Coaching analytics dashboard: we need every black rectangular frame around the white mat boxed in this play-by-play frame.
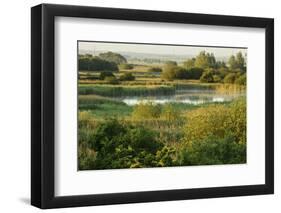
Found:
[31,4,274,209]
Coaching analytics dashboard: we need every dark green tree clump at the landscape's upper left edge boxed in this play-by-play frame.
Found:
[78,55,118,71]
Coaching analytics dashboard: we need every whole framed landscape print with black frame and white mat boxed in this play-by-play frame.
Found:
[31,4,274,208]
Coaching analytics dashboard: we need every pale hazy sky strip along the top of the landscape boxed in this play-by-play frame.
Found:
[78,41,247,57]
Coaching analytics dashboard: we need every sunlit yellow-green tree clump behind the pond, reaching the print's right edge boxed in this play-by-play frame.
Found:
[162,51,246,85]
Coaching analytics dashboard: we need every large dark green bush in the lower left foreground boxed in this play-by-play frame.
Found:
[79,120,164,170]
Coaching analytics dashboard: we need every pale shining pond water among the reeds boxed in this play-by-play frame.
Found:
[121,90,245,106]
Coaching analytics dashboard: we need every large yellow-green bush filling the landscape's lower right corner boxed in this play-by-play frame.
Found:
[178,100,246,165]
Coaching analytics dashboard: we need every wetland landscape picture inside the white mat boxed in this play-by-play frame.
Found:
[77,41,247,171]
